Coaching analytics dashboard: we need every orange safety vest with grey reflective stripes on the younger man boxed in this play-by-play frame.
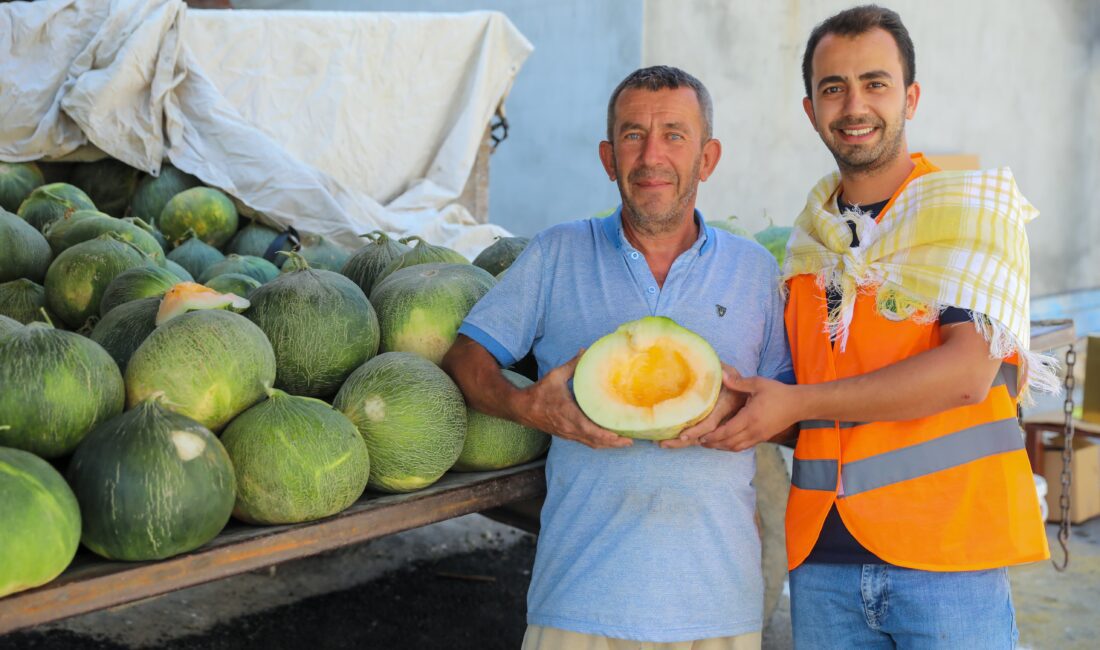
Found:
[785,154,1049,571]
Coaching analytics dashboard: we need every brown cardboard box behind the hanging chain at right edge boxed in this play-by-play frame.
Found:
[1043,436,1100,524]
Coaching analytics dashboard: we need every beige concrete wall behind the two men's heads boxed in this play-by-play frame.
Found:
[642,0,1100,296]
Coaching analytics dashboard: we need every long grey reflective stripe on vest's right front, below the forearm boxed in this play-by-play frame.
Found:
[843,418,1024,497]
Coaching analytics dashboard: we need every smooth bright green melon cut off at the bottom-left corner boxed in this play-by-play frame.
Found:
[0,447,80,598]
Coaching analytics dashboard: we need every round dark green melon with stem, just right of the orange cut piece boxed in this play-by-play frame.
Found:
[243,253,378,397]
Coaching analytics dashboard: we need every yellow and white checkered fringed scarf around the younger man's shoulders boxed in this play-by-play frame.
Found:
[783,168,1059,393]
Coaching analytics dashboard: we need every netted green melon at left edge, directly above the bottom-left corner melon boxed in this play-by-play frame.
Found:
[0,323,124,459]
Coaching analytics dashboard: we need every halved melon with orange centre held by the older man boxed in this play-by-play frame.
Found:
[573,317,722,440]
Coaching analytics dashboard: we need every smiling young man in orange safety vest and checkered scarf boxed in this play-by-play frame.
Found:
[683,5,1054,650]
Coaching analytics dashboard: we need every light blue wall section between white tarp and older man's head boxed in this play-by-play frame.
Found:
[233,0,644,235]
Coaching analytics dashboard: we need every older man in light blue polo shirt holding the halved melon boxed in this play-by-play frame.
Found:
[443,66,793,650]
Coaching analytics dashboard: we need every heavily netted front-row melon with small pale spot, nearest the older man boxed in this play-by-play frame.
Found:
[332,352,466,493]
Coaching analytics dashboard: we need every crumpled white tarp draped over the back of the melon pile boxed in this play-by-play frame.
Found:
[0,0,531,256]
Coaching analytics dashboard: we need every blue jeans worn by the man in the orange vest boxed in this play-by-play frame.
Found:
[791,564,1019,650]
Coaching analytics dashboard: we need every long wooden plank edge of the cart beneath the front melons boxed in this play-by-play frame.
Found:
[0,461,546,634]
